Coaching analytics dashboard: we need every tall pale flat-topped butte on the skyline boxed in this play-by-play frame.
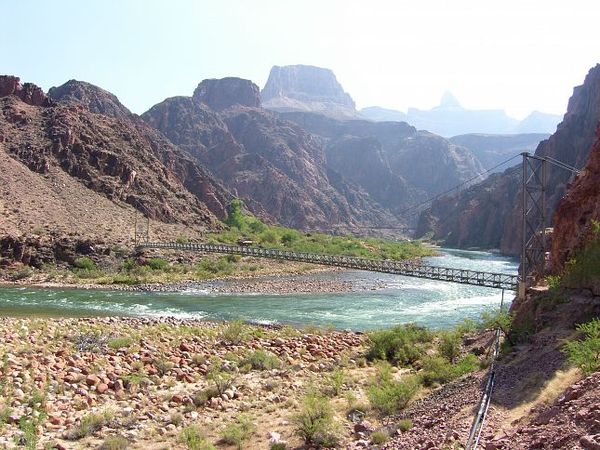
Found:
[261,65,358,118]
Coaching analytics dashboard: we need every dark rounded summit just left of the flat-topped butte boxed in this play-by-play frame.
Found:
[193,77,260,111]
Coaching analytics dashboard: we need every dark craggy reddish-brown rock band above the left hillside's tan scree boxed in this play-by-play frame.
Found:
[0,89,228,226]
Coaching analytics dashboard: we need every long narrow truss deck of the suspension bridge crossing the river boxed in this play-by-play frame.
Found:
[138,242,517,290]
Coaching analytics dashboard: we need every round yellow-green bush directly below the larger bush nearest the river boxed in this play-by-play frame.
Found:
[367,372,420,416]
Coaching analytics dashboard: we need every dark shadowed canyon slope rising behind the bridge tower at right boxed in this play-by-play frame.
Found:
[417,65,600,255]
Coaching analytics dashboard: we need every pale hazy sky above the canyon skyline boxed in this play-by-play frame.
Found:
[0,0,600,118]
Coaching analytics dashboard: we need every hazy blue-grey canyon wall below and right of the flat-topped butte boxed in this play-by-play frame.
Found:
[281,112,483,221]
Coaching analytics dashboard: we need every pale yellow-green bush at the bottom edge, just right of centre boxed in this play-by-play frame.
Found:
[294,393,339,447]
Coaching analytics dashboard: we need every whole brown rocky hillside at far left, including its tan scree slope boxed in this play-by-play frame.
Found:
[0,76,231,266]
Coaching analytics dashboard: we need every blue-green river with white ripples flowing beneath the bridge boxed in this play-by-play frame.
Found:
[0,249,518,331]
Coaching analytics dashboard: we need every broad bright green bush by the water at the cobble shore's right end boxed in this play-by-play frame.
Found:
[367,323,433,365]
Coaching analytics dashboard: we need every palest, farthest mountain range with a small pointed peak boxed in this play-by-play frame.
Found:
[360,92,561,137]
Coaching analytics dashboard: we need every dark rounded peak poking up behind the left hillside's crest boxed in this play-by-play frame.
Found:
[48,80,133,119]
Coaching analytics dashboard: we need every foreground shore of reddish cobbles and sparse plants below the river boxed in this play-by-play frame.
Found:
[0,318,364,449]
